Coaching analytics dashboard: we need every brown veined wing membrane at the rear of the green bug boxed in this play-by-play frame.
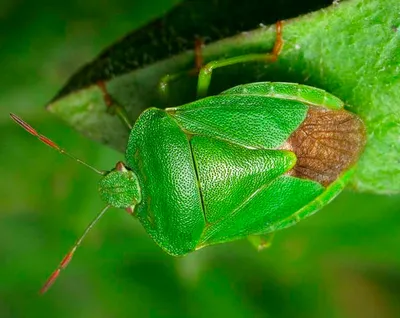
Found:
[282,106,365,186]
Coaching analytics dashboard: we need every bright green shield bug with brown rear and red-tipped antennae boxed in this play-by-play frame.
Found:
[12,21,365,291]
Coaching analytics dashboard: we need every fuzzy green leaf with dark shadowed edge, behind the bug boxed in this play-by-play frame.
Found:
[48,0,400,194]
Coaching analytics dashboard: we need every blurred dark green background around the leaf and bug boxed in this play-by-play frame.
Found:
[0,0,400,317]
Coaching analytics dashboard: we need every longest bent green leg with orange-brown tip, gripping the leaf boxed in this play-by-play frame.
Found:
[197,21,283,98]
